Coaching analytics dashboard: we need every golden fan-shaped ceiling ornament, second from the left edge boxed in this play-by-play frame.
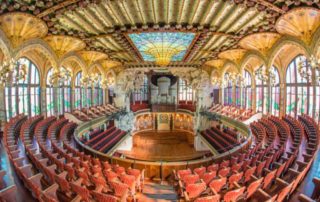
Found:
[44,35,86,58]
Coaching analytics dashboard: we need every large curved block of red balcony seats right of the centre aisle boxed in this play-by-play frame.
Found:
[174,115,320,202]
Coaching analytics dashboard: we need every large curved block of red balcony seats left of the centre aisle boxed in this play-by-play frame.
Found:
[0,115,144,202]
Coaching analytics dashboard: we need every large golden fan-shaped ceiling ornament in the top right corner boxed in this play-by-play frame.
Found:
[276,7,320,43]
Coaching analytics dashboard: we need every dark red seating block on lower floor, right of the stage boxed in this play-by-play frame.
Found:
[200,127,239,153]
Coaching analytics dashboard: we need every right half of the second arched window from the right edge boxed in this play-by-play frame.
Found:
[271,67,280,116]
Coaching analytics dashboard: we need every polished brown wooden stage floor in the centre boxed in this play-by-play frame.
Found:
[117,131,208,161]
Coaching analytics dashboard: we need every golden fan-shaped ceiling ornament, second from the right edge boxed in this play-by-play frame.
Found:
[239,32,281,55]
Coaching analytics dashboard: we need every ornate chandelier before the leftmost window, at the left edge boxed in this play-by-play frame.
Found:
[0,59,27,86]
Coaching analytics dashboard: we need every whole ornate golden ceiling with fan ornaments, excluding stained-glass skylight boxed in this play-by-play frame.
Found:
[0,0,320,71]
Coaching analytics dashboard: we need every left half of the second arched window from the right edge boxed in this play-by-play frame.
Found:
[255,66,269,113]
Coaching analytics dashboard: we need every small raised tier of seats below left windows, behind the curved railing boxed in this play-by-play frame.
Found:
[72,104,119,121]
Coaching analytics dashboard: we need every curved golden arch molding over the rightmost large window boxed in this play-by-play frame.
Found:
[267,36,312,67]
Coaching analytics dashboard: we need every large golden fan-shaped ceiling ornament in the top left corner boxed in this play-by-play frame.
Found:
[0,12,48,48]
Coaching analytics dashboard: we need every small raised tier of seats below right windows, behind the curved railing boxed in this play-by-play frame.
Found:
[209,104,255,121]
